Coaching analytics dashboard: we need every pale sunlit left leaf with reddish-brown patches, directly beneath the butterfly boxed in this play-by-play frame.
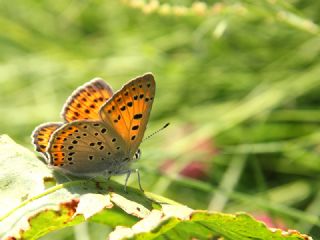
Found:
[0,135,148,239]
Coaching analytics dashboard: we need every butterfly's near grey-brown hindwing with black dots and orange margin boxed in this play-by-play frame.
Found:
[48,120,129,176]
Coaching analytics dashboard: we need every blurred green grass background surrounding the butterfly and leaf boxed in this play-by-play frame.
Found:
[0,0,320,240]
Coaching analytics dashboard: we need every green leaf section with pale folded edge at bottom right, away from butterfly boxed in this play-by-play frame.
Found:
[110,205,311,240]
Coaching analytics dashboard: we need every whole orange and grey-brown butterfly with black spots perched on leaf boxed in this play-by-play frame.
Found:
[32,73,156,189]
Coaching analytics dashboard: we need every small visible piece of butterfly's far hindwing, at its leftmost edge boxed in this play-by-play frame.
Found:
[32,123,62,153]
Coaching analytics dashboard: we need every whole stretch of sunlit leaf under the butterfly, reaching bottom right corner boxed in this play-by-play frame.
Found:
[0,135,311,240]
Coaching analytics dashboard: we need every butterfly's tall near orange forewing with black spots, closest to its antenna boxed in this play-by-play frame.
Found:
[100,73,155,157]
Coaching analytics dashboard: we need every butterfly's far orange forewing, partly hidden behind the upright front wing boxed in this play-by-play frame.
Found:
[61,78,113,122]
